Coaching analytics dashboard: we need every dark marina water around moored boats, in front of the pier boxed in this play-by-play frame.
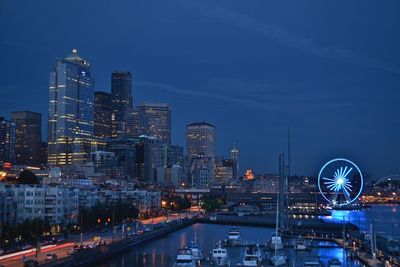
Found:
[96,224,360,267]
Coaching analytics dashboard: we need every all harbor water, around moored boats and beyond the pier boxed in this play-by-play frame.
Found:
[96,205,400,267]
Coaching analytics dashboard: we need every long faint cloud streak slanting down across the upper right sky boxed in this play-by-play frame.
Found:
[180,0,400,74]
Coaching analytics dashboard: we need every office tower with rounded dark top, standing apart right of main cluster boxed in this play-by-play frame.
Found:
[186,122,215,159]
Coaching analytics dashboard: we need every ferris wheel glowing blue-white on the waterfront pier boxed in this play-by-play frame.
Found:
[318,158,364,206]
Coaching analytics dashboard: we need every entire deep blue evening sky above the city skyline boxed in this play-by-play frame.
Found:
[0,0,400,179]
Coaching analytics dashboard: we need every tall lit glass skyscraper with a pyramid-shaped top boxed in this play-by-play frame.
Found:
[48,49,94,166]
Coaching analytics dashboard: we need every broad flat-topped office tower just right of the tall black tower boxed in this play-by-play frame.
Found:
[132,103,171,145]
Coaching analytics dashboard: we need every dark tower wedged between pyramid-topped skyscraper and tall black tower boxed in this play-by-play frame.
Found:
[94,92,112,138]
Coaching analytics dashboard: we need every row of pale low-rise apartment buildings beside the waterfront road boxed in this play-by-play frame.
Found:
[0,184,161,226]
